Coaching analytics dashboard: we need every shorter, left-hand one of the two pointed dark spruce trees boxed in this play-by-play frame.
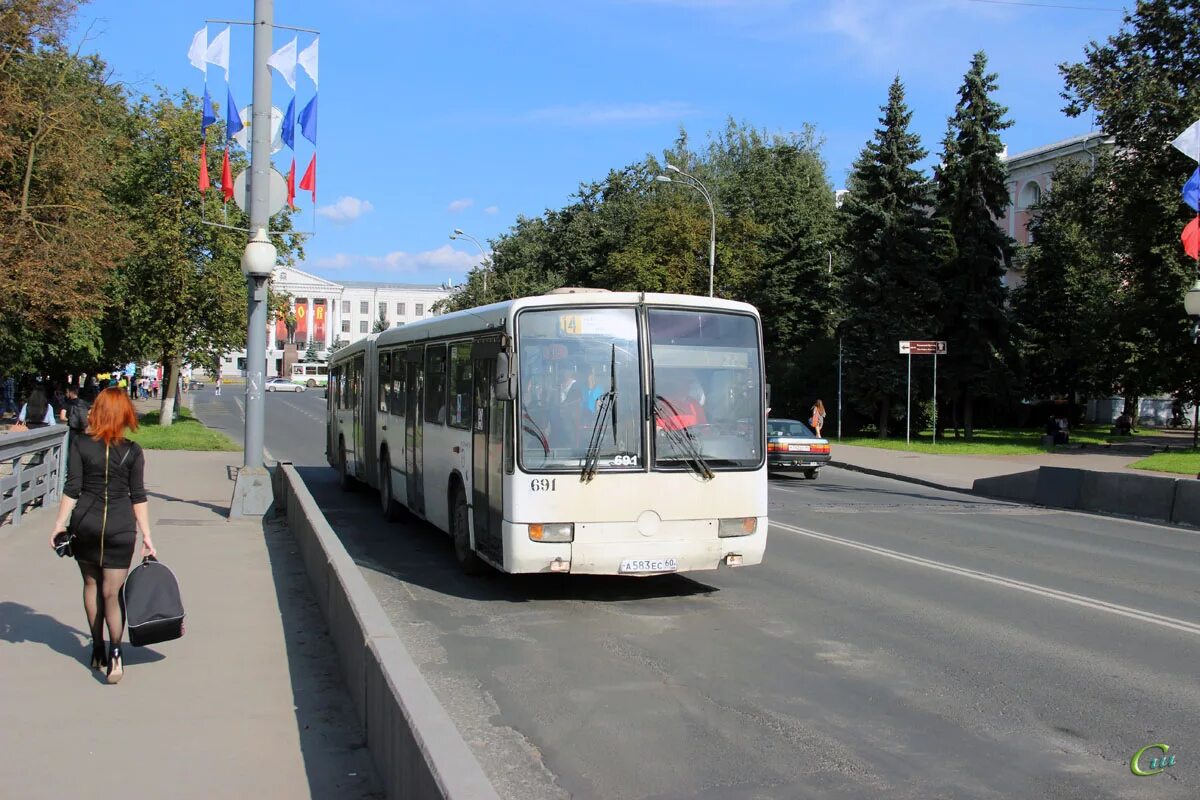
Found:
[842,76,938,438]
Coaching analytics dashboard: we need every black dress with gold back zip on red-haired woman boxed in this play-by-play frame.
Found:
[64,435,146,570]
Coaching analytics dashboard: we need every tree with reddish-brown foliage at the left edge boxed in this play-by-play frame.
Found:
[0,0,128,371]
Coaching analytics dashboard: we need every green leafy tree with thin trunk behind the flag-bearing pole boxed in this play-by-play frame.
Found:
[109,92,301,425]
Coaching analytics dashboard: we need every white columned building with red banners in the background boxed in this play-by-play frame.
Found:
[221,267,452,377]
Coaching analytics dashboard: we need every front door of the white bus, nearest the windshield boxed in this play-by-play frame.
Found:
[470,338,504,565]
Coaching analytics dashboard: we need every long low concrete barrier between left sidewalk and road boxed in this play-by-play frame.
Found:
[275,463,499,800]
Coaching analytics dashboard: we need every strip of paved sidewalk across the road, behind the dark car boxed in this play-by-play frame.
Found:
[830,441,1147,492]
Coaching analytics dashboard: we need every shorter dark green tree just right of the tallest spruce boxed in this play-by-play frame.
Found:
[1013,158,1128,398]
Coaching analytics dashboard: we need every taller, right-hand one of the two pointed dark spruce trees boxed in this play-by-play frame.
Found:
[934,52,1015,439]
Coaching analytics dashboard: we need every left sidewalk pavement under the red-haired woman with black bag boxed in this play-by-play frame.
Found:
[0,451,384,800]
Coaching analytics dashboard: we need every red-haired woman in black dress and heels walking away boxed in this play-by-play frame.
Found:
[50,389,155,684]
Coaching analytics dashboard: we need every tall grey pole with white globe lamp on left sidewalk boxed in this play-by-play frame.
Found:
[229,0,276,517]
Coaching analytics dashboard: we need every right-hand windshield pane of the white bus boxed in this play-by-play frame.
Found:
[649,308,763,473]
